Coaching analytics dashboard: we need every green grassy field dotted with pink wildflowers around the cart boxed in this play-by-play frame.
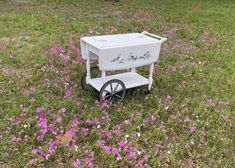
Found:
[0,0,235,168]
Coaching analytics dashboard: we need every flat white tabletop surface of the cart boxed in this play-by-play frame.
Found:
[81,33,161,49]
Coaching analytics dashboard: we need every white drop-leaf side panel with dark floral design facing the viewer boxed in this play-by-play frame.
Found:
[99,43,161,71]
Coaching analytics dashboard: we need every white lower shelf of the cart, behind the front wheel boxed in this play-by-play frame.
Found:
[89,72,149,91]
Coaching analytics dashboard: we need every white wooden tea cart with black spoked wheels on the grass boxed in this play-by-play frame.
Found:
[81,31,167,102]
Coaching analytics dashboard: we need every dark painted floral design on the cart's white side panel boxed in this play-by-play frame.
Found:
[110,51,152,64]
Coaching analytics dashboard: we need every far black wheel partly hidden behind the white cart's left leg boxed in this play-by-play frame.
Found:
[81,66,101,91]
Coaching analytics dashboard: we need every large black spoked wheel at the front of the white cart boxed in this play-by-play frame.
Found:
[100,79,126,103]
